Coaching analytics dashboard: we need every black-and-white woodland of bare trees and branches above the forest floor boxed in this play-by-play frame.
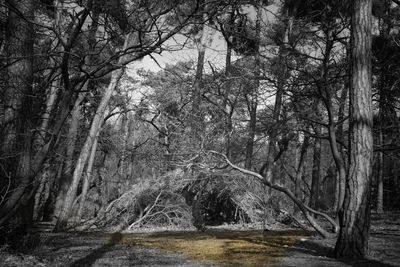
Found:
[0,0,400,258]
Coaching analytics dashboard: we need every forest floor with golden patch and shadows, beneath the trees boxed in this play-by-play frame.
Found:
[0,215,400,267]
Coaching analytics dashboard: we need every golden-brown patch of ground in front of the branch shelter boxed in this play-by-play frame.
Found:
[114,229,307,266]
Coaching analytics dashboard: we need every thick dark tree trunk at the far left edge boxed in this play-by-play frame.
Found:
[0,0,35,228]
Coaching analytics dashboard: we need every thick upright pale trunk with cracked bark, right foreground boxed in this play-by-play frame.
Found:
[335,0,373,259]
